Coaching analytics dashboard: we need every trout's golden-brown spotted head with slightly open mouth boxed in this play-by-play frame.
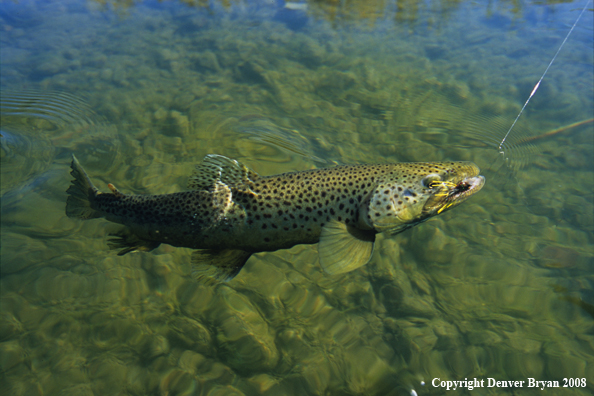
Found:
[359,161,485,234]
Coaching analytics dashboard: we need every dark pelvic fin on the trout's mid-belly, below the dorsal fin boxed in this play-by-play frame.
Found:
[192,249,252,282]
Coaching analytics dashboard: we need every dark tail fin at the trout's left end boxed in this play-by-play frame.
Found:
[66,155,102,220]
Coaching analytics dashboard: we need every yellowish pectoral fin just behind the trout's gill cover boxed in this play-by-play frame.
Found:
[318,220,375,275]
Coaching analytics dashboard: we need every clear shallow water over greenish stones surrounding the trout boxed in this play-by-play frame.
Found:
[0,1,594,395]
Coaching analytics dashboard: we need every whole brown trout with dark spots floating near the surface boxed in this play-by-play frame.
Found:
[66,155,485,280]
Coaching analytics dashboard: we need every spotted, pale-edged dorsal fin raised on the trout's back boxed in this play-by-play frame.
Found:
[188,154,260,190]
